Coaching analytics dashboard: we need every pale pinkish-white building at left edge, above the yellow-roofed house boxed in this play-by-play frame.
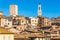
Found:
[0,17,12,27]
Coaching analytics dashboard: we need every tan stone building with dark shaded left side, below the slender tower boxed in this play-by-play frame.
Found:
[38,17,51,27]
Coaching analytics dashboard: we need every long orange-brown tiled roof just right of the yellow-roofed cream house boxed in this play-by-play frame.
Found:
[15,32,44,38]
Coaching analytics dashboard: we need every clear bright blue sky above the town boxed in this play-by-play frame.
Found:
[0,0,60,18]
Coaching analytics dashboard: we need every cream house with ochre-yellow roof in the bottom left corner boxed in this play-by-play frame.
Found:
[0,27,14,40]
